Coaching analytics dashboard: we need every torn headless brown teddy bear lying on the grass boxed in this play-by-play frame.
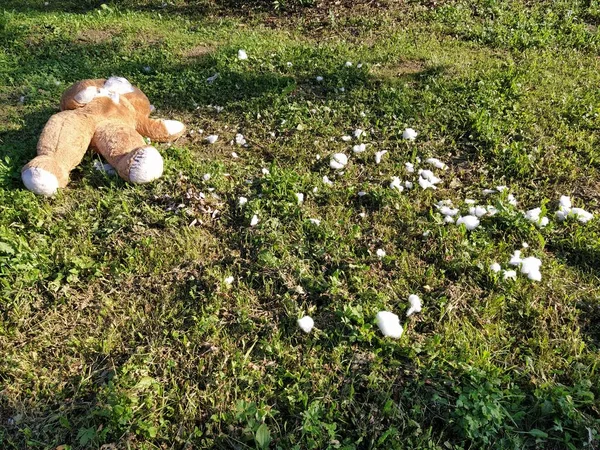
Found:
[21,77,185,196]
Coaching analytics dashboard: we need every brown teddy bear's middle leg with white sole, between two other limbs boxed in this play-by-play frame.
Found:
[92,123,163,183]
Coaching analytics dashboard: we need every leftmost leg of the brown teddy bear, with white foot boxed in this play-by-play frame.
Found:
[21,111,94,196]
